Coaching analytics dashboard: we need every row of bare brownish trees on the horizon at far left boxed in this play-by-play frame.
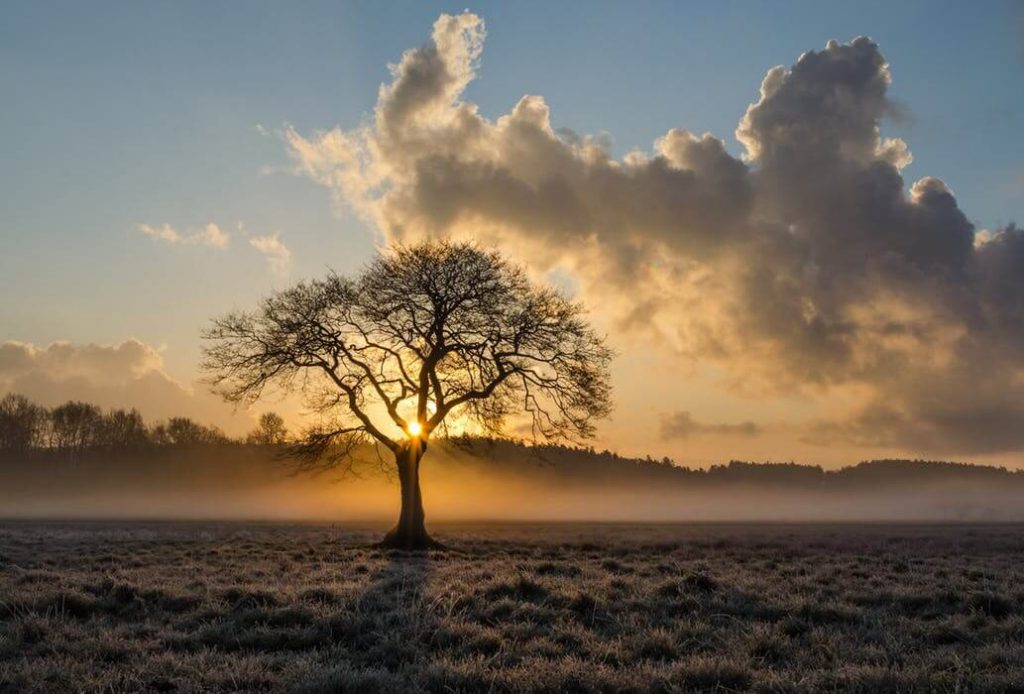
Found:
[0,393,288,456]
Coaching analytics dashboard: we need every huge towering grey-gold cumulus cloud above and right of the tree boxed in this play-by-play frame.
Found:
[286,12,1024,451]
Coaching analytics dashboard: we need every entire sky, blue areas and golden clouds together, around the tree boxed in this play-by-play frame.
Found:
[0,1,1024,467]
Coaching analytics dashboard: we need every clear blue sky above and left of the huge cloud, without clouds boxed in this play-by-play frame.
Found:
[0,0,1024,464]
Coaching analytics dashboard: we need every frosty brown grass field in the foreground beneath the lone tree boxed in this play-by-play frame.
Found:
[0,522,1024,692]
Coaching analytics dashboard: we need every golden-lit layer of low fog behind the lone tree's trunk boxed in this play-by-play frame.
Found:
[0,442,1024,522]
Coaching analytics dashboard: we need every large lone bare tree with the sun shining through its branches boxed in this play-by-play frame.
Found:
[204,242,612,549]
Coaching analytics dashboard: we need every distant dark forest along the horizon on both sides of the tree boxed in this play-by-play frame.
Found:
[0,393,1024,489]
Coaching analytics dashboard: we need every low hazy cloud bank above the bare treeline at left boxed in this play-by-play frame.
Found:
[0,339,252,433]
